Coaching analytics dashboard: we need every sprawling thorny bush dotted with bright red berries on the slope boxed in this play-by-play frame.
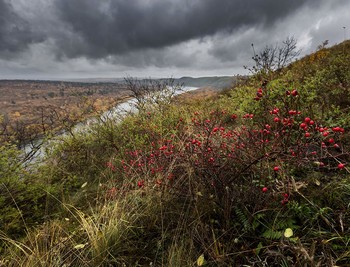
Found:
[106,85,348,215]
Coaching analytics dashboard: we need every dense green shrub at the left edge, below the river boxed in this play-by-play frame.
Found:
[0,145,54,244]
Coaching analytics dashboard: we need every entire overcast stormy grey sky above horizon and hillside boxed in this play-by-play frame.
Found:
[0,0,350,79]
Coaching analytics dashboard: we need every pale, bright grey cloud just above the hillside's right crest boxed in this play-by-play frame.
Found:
[208,0,350,66]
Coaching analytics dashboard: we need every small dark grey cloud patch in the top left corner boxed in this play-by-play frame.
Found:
[0,0,43,56]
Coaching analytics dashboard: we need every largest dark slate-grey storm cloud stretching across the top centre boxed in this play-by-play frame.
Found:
[55,0,320,58]
